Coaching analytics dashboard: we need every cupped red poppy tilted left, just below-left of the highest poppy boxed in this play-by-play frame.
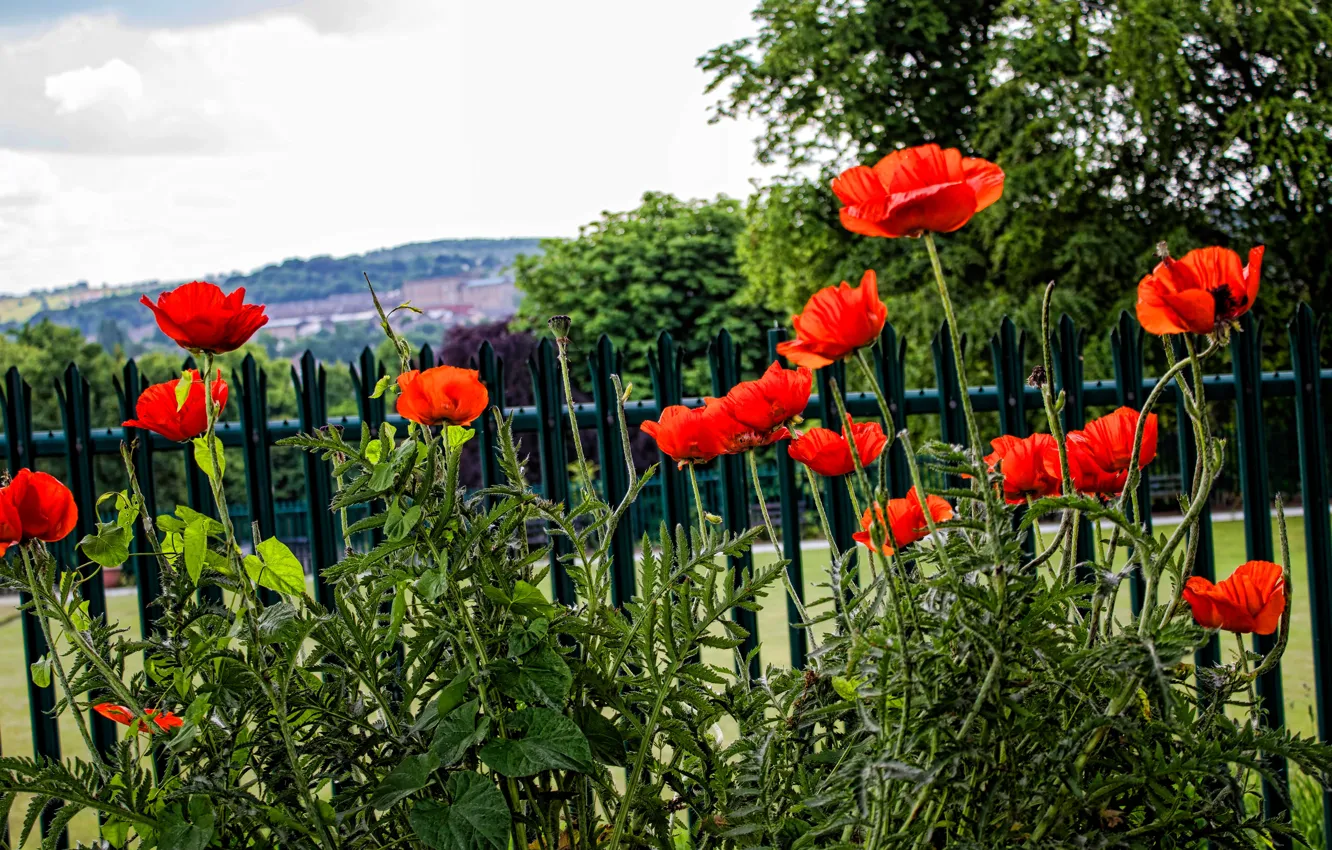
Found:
[777,269,888,369]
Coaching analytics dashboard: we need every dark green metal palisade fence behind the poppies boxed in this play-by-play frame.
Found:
[0,305,1332,834]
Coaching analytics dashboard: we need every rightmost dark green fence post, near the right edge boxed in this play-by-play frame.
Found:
[1288,301,1332,835]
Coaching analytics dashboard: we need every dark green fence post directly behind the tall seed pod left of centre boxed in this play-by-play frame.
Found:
[527,337,579,605]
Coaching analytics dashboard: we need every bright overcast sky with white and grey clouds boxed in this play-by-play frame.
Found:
[0,0,763,292]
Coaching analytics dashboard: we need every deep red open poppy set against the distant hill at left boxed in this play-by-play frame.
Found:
[139,280,268,354]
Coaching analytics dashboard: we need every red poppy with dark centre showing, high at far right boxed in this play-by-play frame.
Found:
[1138,245,1263,334]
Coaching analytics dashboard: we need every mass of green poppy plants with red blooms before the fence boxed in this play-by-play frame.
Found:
[0,143,1332,850]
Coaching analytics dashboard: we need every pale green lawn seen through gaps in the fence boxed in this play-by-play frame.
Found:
[0,517,1316,846]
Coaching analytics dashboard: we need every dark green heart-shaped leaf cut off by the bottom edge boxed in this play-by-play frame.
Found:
[408,770,506,850]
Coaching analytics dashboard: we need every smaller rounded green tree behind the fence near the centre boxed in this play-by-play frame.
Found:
[515,192,777,393]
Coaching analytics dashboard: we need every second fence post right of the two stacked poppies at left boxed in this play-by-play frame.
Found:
[292,349,340,610]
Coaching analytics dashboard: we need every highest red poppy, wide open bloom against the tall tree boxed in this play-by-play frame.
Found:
[833,145,1003,237]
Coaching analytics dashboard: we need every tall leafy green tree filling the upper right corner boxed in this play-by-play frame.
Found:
[699,0,1332,375]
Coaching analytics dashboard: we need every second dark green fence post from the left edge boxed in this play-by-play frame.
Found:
[56,364,116,755]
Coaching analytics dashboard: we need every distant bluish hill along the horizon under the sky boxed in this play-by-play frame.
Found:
[0,238,539,338]
